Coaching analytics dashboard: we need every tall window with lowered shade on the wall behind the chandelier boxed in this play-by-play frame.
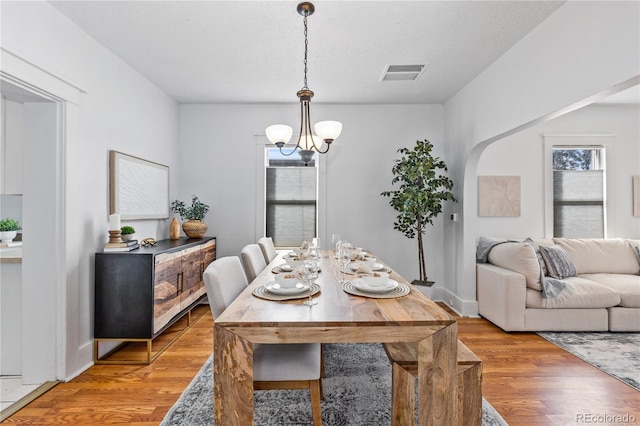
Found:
[265,148,318,247]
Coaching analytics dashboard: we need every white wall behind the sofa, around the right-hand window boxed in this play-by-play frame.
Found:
[476,104,640,239]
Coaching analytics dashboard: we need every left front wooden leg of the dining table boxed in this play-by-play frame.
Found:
[213,326,253,426]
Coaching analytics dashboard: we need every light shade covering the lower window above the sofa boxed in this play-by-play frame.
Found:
[553,170,604,238]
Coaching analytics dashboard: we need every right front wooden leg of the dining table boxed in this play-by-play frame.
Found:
[418,323,458,426]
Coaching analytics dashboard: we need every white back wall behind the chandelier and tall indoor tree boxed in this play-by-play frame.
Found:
[179,104,444,285]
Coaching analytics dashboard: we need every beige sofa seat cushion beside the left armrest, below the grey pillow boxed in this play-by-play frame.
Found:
[526,277,620,309]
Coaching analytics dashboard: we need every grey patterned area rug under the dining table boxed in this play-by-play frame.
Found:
[161,344,507,426]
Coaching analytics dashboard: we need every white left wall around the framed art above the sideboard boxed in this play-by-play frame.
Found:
[0,1,178,379]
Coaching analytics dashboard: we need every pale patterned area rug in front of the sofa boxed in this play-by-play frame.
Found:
[538,332,640,391]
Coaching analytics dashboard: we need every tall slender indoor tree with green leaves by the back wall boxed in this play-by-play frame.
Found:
[380,139,455,286]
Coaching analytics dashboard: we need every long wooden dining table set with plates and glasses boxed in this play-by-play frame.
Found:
[213,251,458,426]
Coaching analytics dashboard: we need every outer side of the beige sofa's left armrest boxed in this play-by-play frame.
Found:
[476,263,527,331]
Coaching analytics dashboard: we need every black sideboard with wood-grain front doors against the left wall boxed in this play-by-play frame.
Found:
[94,237,216,364]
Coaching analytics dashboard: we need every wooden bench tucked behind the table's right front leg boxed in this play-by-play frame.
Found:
[384,340,482,426]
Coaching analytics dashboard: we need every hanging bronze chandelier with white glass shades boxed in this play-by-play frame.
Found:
[265,2,342,166]
